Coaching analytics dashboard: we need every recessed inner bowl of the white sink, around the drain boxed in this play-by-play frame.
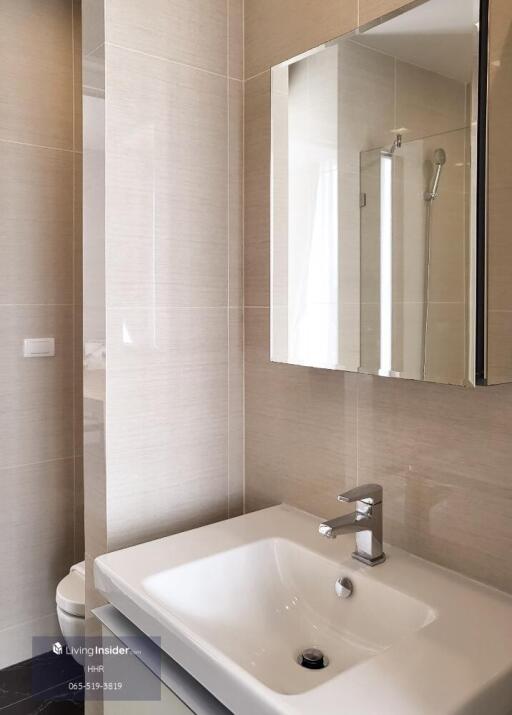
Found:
[143,538,435,694]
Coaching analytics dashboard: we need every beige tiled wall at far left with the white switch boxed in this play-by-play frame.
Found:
[0,0,83,668]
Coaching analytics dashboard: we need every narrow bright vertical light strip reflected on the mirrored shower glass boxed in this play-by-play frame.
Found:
[379,154,393,375]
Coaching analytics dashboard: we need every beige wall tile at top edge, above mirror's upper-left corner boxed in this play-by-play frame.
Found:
[245,0,357,78]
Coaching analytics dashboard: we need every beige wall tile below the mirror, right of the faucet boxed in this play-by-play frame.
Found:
[358,377,512,590]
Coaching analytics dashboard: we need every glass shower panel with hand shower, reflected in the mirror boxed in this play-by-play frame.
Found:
[360,129,468,384]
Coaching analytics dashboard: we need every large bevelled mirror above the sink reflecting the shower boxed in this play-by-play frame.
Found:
[271,0,486,385]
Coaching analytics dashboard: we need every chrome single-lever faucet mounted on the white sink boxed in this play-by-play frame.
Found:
[318,484,386,566]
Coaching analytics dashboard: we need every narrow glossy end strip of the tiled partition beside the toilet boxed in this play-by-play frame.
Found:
[82,0,107,632]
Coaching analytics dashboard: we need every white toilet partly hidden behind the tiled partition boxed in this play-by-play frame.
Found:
[55,561,85,665]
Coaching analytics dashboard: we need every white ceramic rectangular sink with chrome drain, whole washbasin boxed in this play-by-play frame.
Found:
[95,505,512,715]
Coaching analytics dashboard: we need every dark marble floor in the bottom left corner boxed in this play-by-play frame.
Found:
[0,653,84,715]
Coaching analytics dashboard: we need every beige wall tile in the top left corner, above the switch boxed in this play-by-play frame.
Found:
[0,0,73,149]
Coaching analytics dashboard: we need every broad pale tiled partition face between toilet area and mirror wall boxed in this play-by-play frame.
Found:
[84,0,243,563]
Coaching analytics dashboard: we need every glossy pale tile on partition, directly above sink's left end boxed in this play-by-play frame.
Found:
[106,308,228,549]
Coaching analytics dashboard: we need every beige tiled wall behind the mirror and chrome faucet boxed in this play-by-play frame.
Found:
[245,0,512,591]
